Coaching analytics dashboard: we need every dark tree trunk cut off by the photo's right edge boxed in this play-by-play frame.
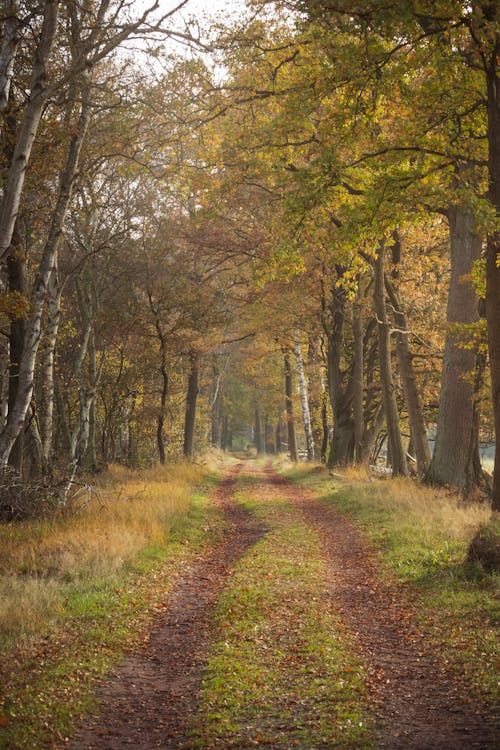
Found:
[486,51,500,511]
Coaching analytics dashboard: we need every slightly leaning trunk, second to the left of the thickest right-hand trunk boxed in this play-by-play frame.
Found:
[373,243,408,476]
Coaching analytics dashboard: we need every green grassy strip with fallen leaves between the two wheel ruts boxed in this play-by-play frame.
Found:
[193,477,372,749]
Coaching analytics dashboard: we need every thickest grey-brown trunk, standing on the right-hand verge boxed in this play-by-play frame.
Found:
[426,206,482,491]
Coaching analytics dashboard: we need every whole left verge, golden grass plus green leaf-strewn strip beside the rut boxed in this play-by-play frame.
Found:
[0,465,223,750]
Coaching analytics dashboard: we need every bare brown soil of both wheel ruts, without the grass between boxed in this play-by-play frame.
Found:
[70,465,500,750]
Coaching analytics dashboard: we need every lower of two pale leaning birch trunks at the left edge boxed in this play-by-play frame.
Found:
[0,85,90,466]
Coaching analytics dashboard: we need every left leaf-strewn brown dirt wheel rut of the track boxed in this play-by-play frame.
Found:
[71,466,266,750]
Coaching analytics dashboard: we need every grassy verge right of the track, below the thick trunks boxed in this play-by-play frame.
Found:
[288,469,500,700]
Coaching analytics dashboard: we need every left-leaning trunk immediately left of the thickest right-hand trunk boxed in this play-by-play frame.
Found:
[385,235,431,477]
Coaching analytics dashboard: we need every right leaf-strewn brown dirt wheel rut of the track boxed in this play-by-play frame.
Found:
[266,468,500,750]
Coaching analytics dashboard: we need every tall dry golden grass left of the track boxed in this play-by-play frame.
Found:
[0,464,206,648]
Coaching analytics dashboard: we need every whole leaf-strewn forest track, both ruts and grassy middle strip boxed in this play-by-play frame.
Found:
[65,461,500,750]
